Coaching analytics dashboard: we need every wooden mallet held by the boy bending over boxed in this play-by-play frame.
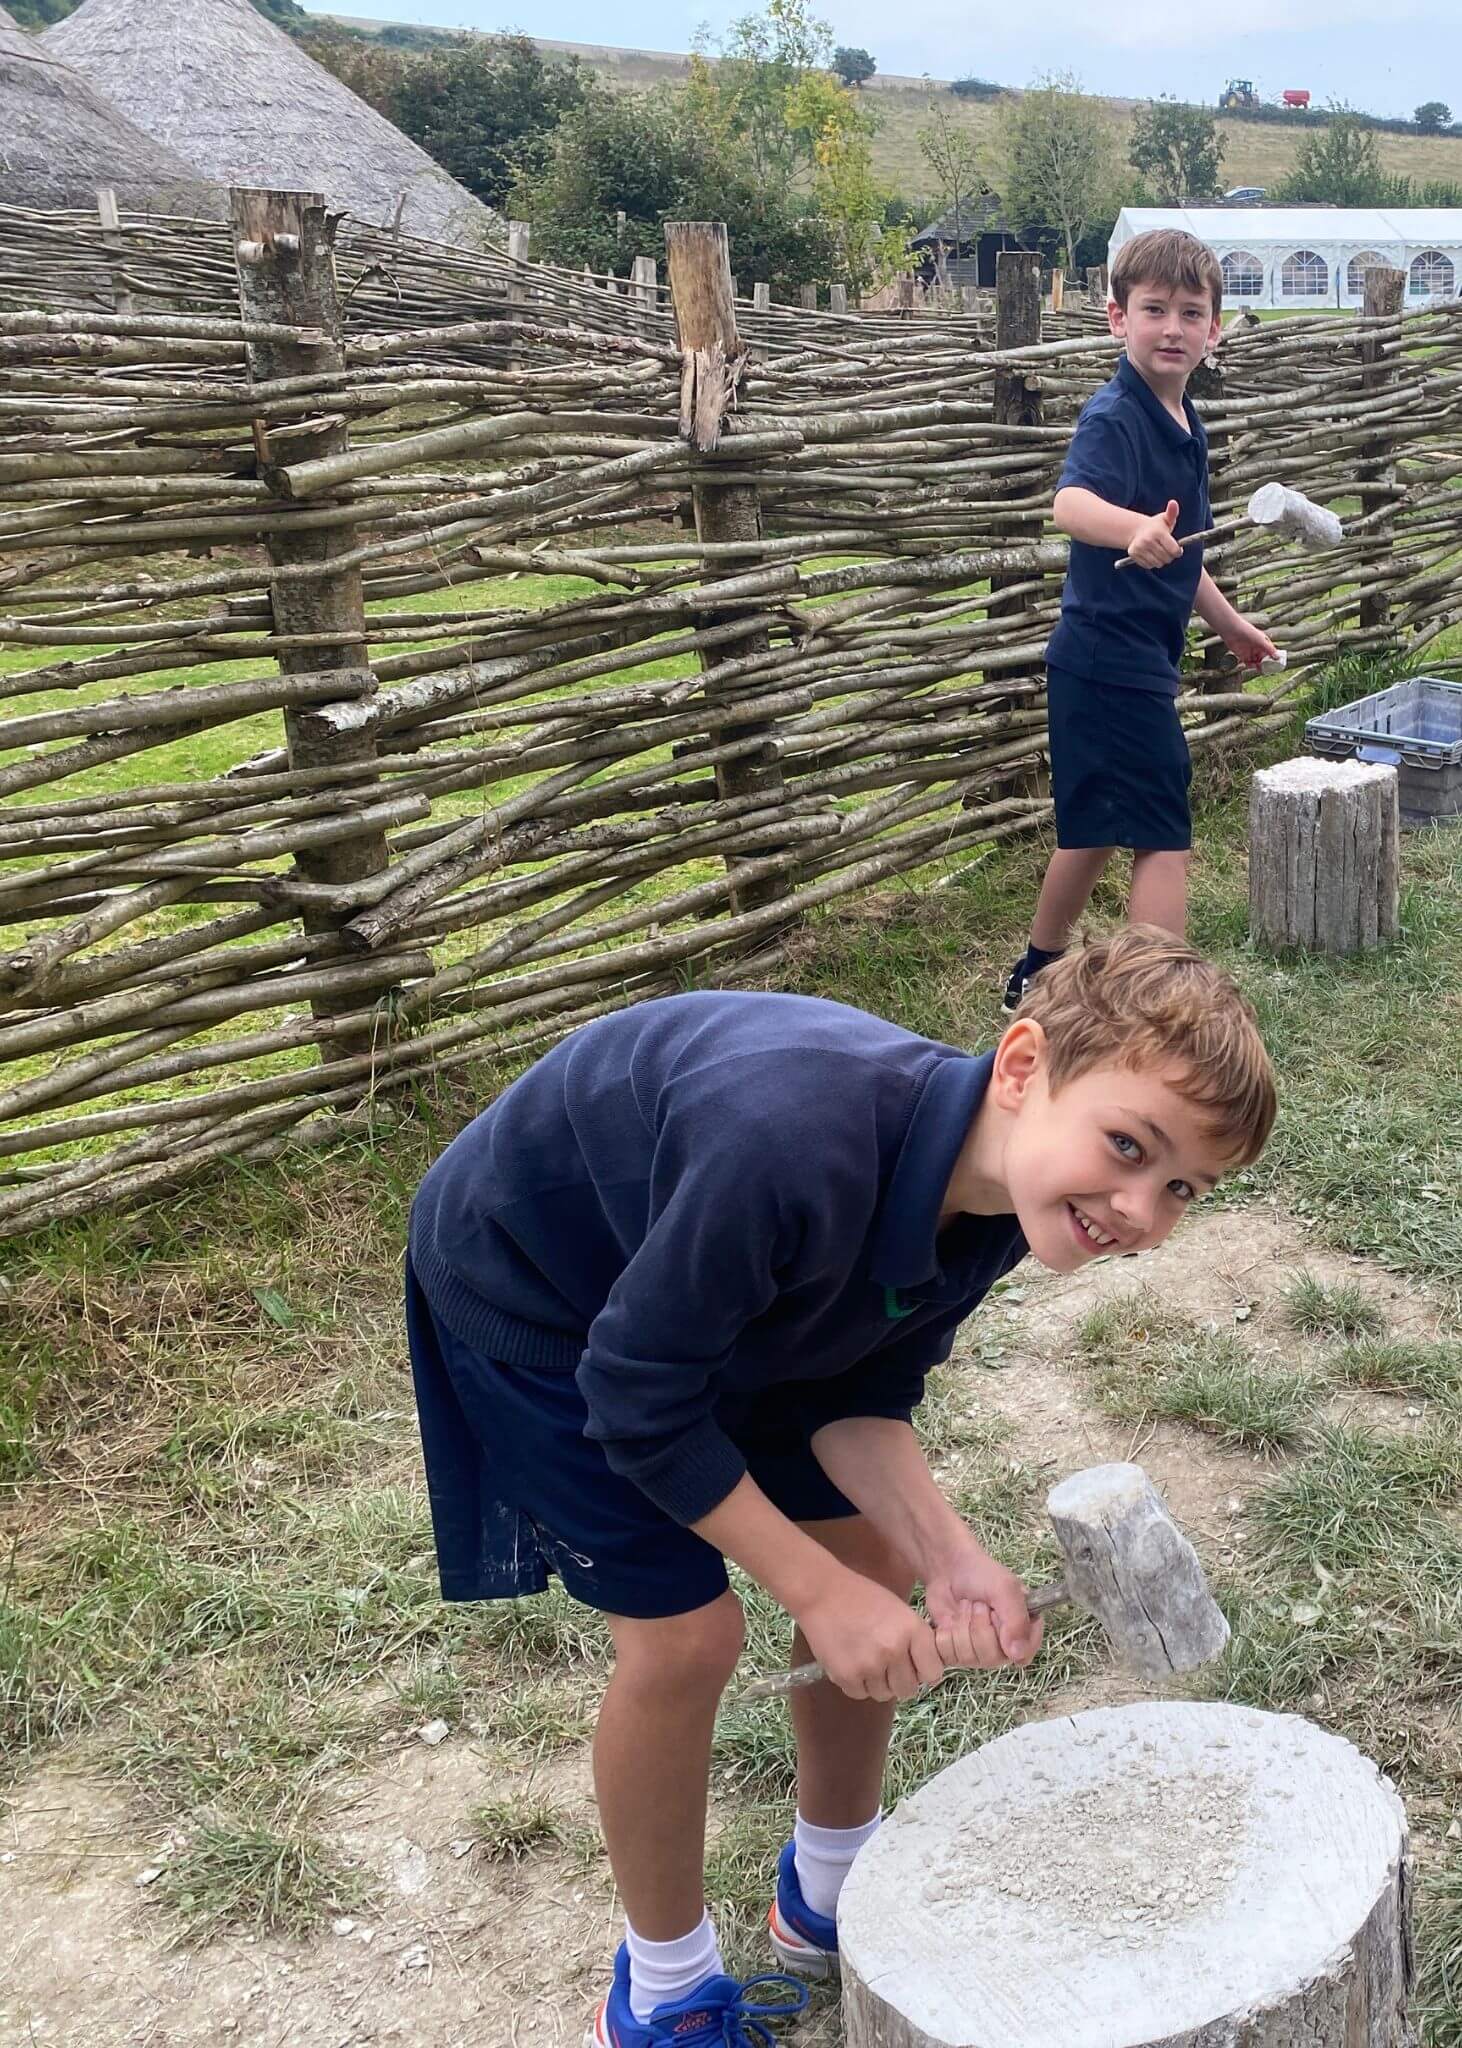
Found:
[741,1464,1229,1700]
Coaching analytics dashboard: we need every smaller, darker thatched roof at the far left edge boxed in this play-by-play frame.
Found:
[0,6,227,219]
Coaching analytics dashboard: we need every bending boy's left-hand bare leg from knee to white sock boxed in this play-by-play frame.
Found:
[594,1593,745,1942]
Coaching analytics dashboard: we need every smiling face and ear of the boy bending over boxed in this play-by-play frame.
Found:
[989,1024,1235,1272]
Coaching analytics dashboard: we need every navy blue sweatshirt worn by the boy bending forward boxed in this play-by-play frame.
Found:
[412,991,1026,1524]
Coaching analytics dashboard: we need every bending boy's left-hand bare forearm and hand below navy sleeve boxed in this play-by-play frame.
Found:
[690,1474,937,1700]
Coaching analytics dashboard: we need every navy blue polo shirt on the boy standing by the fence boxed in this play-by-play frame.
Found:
[1046,356,1210,696]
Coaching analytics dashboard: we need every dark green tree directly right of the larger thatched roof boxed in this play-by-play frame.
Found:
[370,35,586,207]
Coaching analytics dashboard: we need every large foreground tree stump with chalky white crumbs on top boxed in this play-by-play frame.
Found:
[837,1702,1413,2048]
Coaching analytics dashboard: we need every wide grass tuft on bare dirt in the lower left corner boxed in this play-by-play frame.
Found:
[156,1804,367,1939]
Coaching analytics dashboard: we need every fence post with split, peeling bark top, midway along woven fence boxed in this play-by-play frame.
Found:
[665,221,792,911]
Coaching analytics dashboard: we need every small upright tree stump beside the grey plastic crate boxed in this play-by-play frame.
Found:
[1249,758,1401,954]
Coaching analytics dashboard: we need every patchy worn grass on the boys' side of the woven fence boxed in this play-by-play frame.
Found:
[0,655,1462,2048]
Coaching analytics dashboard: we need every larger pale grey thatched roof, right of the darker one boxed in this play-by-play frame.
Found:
[41,0,496,246]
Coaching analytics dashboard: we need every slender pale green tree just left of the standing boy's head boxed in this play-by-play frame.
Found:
[999,72,1116,270]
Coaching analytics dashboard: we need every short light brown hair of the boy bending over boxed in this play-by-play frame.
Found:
[1020,924,1276,1165]
